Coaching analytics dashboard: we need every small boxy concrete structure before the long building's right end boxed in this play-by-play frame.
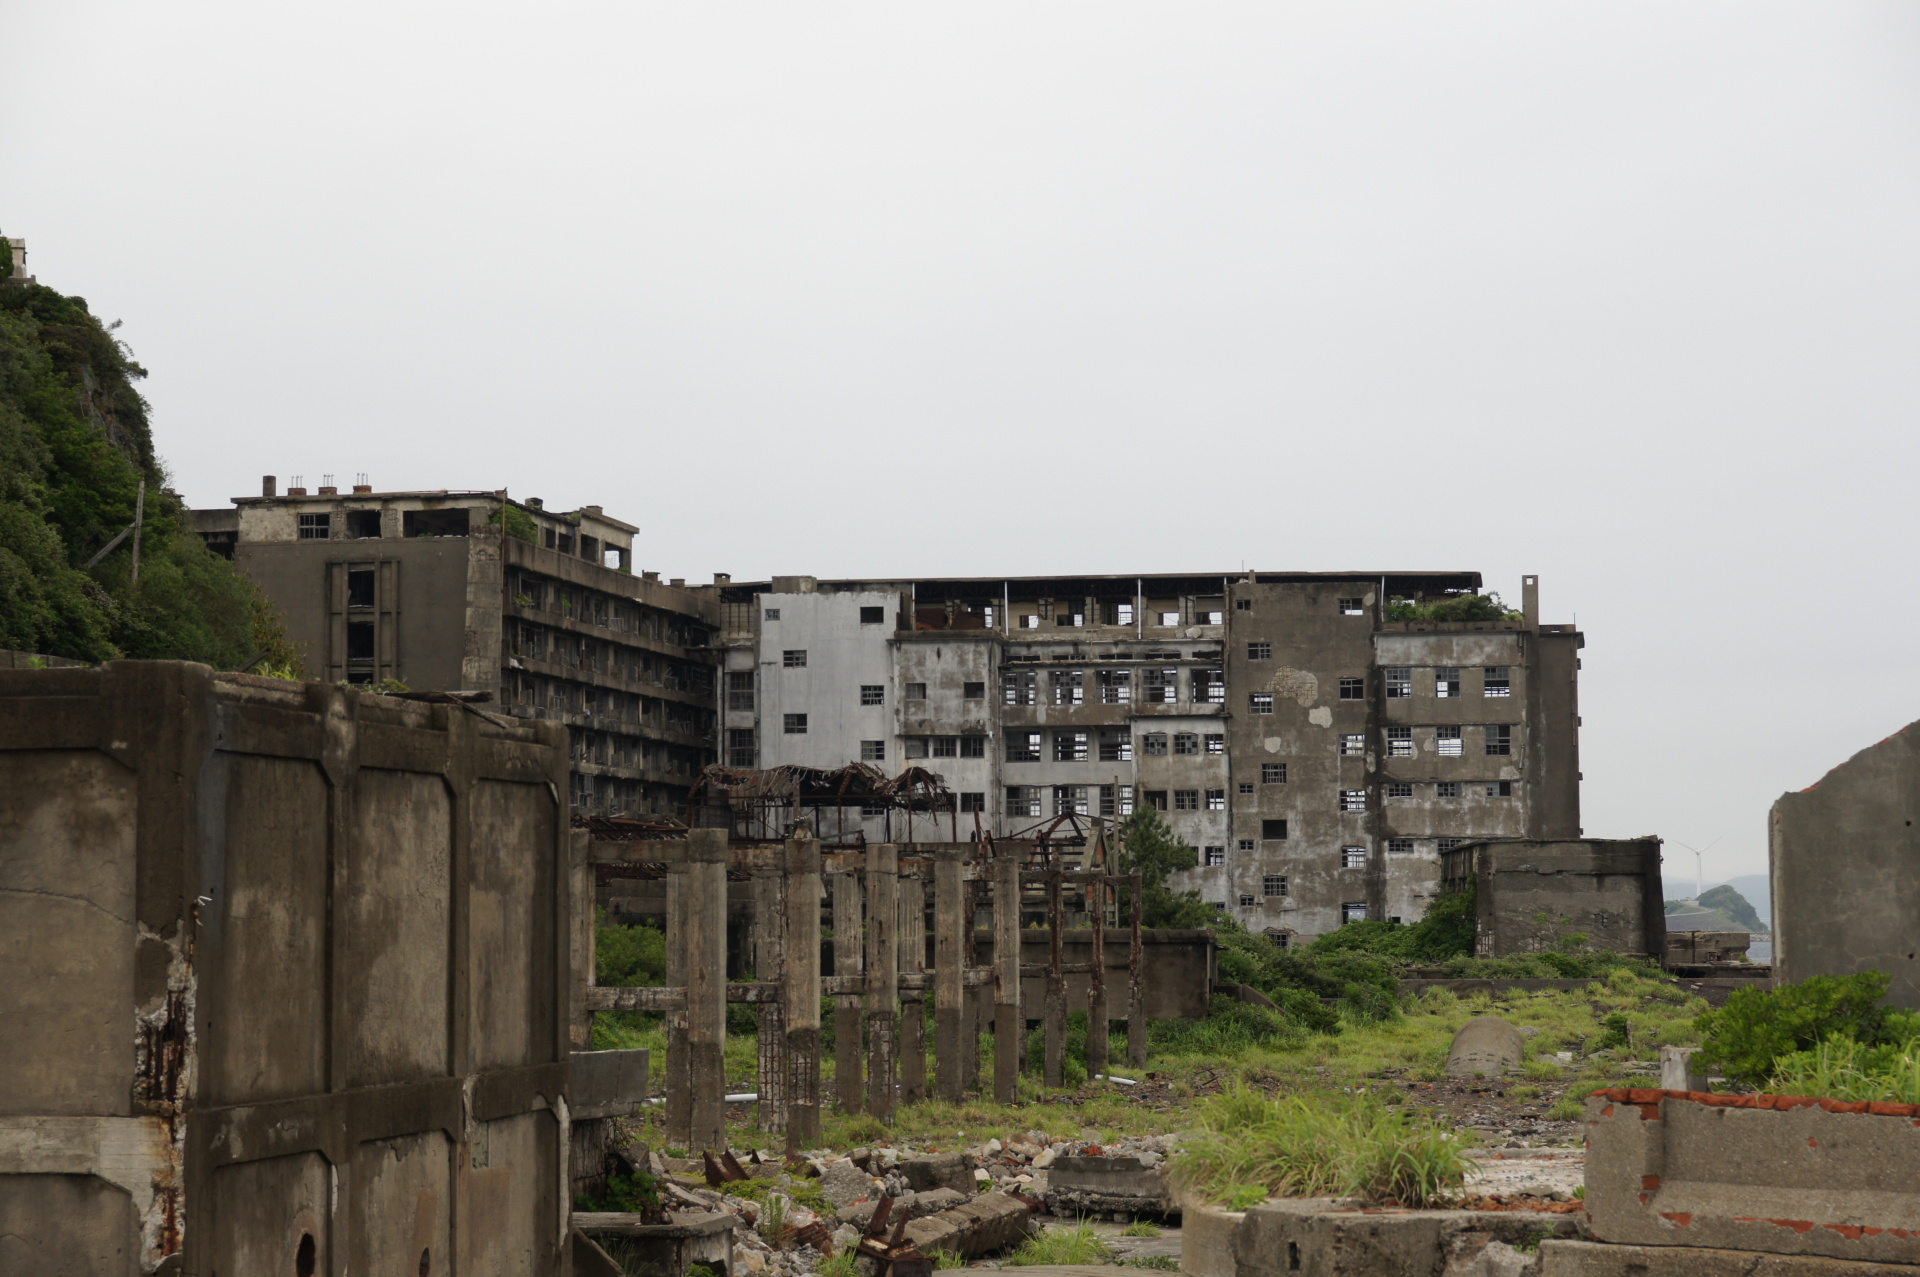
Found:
[1446,837,1667,958]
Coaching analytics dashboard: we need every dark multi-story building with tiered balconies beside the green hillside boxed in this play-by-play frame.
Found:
[194,476,718,814]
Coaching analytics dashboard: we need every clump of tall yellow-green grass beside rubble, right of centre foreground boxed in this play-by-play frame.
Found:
[1173,1089,1469,1208]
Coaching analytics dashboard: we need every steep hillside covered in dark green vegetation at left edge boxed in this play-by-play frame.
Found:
[0,270,301,674]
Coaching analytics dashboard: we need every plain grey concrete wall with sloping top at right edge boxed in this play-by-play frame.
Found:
[1768,724,1920,1006]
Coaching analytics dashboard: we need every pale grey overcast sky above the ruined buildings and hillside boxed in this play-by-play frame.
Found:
[0,0,1920,891]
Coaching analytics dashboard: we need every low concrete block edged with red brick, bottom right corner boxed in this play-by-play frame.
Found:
[1586,1089,1920,1264]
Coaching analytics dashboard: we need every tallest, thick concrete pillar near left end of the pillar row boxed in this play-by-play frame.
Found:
[682,830,726,1150]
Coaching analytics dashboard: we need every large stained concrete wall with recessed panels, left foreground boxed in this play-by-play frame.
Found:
[0,663,568,1277]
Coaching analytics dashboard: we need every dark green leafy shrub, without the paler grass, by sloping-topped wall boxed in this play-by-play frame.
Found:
[1699,972,1920,1087]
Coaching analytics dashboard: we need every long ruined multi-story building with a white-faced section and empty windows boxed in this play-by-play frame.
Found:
[712,572,1582,939]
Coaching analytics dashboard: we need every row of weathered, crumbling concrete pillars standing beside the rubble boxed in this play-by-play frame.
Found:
[588,830,1146,1148]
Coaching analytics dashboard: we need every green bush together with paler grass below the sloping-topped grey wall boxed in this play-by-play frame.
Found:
[1697,972,1920,1102]
